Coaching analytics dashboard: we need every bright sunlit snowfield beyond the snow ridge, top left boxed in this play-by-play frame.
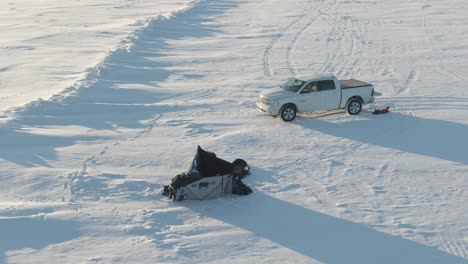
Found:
[0,0,190,111]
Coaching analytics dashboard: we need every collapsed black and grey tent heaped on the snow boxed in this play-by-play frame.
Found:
[163,146,252,201]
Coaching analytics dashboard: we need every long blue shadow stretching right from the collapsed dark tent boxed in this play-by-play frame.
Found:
[192,190,466,264]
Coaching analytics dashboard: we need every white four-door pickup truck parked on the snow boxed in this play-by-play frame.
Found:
[257,76,374,121]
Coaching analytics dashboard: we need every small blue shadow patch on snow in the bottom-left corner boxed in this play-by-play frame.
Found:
[0,217,80,264]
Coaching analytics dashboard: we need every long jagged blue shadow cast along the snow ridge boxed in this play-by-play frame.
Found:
[0,1,236,167]
